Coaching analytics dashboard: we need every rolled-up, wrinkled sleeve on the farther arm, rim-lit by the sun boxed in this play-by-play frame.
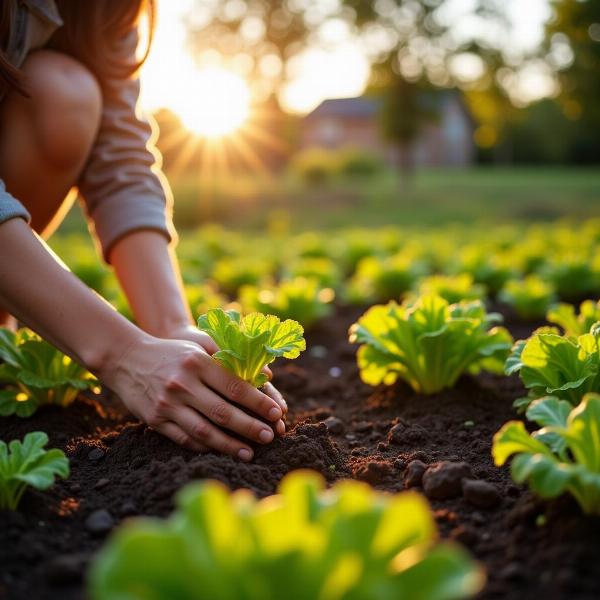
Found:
[79,31,176,261]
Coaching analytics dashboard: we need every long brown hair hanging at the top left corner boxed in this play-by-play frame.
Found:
[0,0,156,94]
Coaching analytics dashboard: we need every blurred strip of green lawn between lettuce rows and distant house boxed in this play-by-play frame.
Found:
[56,167,600,237]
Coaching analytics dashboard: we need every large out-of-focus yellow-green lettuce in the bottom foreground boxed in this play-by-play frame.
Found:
[89,471,484,600]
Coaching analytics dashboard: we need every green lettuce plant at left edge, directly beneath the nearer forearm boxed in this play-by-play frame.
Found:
[0,329,98,417]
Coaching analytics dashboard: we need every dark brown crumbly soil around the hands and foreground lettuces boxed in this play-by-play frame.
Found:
[0,309,600,600]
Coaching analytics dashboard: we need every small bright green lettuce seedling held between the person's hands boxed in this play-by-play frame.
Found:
[198,308,306,387]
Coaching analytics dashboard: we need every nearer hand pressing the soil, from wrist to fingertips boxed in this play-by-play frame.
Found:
[97,335,285,462]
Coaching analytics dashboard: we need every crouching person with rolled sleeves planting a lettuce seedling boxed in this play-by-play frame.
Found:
[0,0,287,461]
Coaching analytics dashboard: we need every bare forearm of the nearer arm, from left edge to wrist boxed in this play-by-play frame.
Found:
[0,219,143,373]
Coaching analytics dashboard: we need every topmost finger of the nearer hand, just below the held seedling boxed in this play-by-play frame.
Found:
[202,360,283,422]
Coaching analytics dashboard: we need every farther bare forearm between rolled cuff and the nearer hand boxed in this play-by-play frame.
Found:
[110,231,192,337]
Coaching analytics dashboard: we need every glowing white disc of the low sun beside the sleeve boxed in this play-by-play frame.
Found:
[173,67,250,138]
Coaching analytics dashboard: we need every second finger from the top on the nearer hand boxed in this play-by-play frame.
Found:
[182,381,278,444]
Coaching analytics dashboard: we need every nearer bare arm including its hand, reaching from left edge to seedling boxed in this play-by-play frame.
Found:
[0,219,283,460]
